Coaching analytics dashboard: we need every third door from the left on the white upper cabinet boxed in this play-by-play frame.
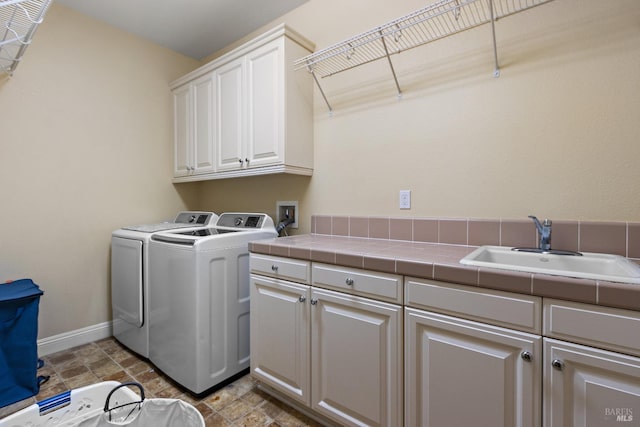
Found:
[214,57,246,171]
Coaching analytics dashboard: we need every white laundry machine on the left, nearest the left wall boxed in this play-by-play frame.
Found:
[111,211,218,357]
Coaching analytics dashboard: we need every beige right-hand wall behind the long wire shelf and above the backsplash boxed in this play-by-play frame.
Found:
[201,0,640,232]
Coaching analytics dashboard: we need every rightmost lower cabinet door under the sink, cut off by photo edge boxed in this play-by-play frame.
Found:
[544,338,640,427]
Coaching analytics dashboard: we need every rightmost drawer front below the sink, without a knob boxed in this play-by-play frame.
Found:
[544,299,640,356]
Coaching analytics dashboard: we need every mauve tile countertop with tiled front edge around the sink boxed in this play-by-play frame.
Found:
[249,234,640,311]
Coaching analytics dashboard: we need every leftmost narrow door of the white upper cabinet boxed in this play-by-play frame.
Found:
[173,84,191,176]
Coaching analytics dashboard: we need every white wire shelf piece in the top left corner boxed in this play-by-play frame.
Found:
[0,0,52,75]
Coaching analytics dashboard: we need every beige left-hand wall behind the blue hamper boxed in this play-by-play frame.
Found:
[0,4,197,338]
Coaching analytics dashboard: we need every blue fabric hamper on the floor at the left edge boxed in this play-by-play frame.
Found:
[0,279,44,407]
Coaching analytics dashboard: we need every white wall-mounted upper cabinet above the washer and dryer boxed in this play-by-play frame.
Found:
[171,25,313,182]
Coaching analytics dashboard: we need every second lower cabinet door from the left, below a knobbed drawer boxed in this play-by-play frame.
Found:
[311,288,403,427]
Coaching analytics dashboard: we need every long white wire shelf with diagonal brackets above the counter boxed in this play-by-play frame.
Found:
[294,0,553,113]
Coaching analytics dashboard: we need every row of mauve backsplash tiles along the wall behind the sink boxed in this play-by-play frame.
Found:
[311,215,640,260]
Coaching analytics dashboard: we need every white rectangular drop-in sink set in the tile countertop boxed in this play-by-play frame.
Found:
[460,246,640,284]
